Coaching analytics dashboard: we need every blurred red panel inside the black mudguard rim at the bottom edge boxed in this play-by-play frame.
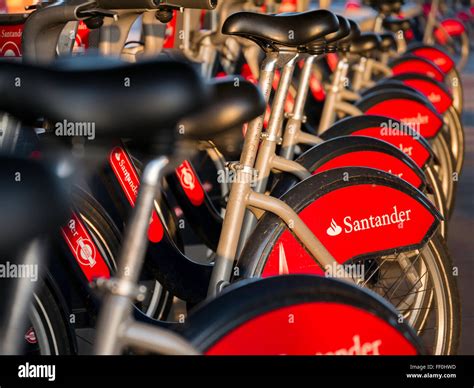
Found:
[206,302,417,355]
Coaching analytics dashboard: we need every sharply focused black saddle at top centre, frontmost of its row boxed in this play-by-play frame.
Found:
[222,10,339,51]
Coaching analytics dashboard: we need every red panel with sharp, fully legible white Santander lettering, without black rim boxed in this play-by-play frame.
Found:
[263,184,437,277]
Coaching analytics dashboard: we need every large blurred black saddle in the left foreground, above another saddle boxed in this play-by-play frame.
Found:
[0,58,208,146]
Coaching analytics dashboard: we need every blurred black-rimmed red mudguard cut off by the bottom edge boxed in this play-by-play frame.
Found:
[183,275,424,355]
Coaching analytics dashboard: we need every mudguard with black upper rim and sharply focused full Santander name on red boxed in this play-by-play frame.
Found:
[262,167,441,277]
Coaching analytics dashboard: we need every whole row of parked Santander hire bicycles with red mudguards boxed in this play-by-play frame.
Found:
[0,0,464,355]
